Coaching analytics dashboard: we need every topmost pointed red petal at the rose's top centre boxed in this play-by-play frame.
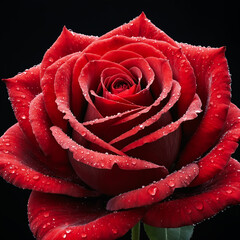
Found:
[100,13,177,46]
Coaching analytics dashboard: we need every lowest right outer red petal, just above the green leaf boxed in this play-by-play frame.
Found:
[144,159,240,228]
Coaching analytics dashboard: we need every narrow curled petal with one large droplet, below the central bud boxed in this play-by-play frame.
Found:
[107,163,198,211]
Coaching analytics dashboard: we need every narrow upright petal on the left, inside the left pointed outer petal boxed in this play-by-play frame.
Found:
[29,93,72,176]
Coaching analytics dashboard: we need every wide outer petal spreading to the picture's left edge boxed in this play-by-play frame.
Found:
[0,124,97,197]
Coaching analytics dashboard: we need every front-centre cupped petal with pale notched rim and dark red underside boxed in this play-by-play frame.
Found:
[51,127,168,195]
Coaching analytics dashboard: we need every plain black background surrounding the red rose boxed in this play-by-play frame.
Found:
[0,0,240,240]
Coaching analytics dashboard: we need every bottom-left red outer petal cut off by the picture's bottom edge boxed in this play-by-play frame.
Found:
[28,192,143,240]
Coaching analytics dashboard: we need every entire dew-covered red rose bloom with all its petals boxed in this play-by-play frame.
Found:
[0,14,240,240]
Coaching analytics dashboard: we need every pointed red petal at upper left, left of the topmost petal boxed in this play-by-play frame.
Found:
[41,27,97,77]
